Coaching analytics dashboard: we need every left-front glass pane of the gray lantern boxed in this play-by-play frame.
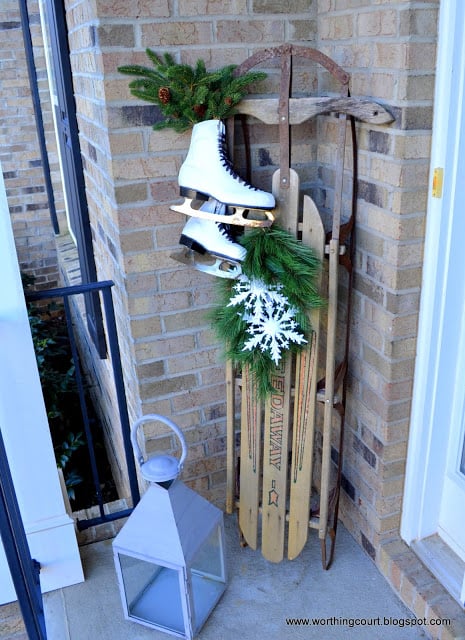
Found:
[118,553,184,633]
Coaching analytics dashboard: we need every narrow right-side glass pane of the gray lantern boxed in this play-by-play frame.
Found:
[191,526,226,631]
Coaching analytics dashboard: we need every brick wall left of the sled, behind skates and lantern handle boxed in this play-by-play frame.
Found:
[62,0,316,504]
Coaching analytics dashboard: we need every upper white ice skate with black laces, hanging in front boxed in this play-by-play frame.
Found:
[171,120,275,226]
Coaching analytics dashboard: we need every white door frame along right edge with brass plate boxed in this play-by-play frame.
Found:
[401,0,465,596]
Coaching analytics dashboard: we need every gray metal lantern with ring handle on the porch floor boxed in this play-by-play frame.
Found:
[113,414,226,640]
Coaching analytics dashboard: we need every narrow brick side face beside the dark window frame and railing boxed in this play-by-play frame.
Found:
[59,0,139,498]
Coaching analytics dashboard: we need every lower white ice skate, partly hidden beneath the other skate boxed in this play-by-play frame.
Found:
[179,199,246,278]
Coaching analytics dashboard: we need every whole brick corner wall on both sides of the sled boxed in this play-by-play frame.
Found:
[61,0,438,558]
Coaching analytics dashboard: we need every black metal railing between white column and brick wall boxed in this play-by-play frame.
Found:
[25,280,140,530]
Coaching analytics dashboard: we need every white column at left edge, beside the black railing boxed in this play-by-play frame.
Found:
[0,165,83,604]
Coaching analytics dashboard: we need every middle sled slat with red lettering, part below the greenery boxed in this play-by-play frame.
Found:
[261,361,292,562]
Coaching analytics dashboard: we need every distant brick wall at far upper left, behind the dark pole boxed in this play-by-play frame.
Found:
[0,0,64,289]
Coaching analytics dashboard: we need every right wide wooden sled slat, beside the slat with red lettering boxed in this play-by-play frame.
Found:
[287,195,325,560]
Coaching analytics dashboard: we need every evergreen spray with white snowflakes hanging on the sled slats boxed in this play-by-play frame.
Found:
[210,224,324,399]
